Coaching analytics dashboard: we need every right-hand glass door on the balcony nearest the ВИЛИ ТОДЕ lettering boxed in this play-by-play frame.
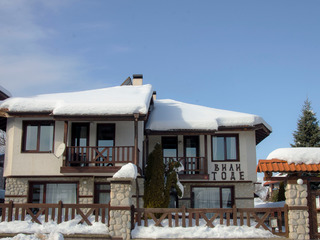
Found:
[184,136,200,174]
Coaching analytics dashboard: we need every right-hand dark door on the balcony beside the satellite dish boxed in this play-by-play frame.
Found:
[97,124,115,166]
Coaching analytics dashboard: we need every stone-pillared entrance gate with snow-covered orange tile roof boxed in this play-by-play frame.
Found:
[257,148,320,239]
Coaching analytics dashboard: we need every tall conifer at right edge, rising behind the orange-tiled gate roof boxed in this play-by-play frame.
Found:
[291,99,320,147]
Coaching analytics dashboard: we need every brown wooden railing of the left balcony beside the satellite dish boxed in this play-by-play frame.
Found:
[64,146,134,167]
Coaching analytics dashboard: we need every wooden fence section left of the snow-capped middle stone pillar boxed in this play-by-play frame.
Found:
[0,201,110,225]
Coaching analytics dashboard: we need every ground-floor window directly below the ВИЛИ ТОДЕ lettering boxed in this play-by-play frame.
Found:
[192,186,234,208]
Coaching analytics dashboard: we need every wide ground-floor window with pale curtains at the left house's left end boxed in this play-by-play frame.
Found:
[29,183,78,203]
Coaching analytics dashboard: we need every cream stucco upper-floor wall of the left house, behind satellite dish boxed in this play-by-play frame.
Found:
[4,118,143,177]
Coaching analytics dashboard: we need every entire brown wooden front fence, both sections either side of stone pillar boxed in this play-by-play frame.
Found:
[0,201,289,237]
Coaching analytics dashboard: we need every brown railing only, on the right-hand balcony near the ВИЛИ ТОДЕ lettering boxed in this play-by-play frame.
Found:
[163,157,206,174]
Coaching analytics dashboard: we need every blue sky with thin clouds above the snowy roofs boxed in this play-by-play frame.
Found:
[0,0,320,165]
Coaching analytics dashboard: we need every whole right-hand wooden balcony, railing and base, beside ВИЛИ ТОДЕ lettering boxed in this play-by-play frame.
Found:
[163,157,209,179]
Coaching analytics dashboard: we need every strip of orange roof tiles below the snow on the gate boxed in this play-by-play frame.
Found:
[257,159,320,172]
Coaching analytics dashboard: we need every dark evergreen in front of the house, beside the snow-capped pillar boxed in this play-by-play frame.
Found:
[144,144,182,208]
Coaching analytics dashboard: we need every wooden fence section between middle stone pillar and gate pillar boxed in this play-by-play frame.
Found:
[134,205,289,236]
